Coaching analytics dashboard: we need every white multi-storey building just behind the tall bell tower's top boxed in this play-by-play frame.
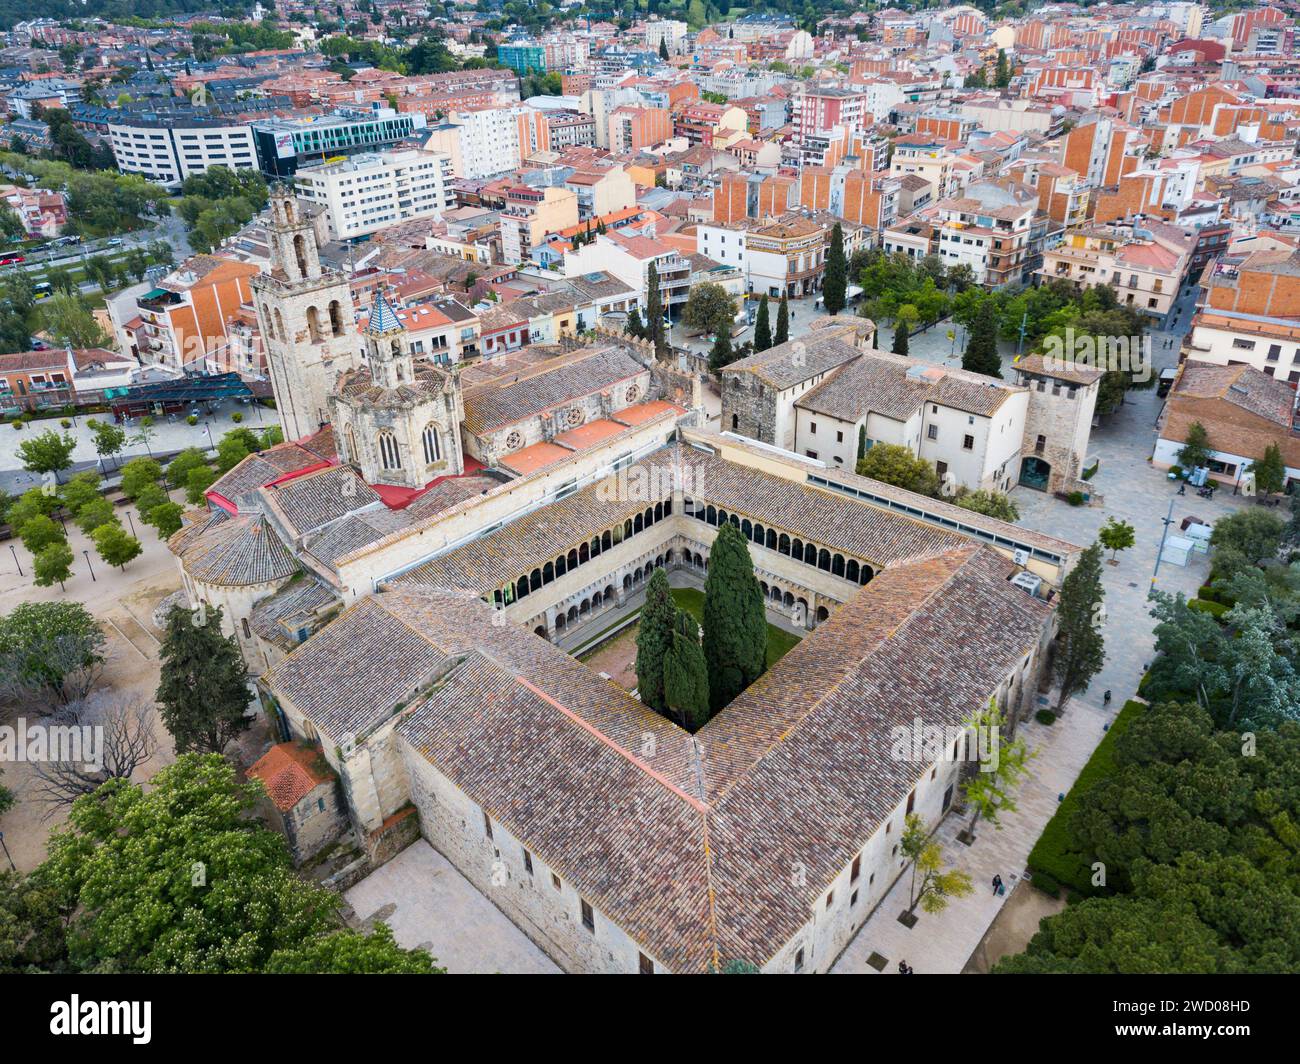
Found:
[295,148,454,239]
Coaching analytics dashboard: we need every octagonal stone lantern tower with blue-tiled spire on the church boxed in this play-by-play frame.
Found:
[329,294,465,490]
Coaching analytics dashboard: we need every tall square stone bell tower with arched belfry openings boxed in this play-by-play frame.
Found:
[252,185,358,440]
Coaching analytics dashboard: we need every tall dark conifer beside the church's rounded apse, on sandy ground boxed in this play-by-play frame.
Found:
[156,606,252,753]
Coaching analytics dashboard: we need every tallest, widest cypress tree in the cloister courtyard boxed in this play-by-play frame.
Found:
[705,522,767,713]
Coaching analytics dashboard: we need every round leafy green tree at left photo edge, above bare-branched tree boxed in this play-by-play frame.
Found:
[0,602,104,702]
